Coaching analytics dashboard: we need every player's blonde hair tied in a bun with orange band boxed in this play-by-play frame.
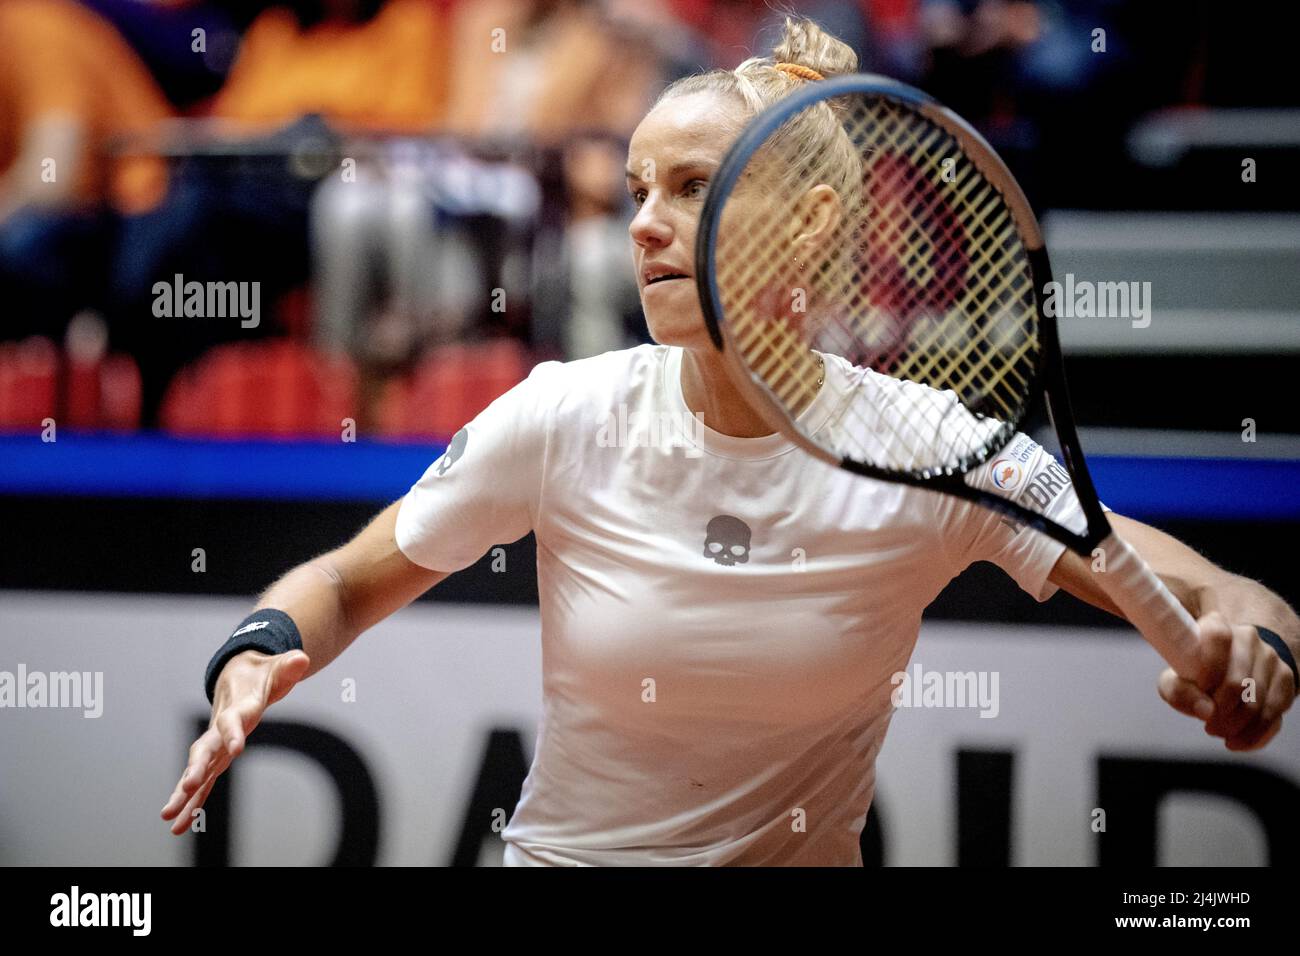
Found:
[654,17,862,297]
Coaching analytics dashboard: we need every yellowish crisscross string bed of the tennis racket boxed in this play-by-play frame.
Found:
[716,89,1039,473]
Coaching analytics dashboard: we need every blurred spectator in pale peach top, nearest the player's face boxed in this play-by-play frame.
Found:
[436,0,681,358]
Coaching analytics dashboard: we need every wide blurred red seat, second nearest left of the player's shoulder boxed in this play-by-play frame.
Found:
[161,339,358,437]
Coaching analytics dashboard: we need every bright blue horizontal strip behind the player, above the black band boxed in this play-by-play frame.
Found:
[0,432,1300,520]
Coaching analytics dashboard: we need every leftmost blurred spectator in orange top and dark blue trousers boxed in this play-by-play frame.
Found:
[0,0,172,337]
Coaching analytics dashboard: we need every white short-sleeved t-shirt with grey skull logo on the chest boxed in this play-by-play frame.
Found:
[397,346,1084,865]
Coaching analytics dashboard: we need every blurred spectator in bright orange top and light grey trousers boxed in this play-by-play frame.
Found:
[226,0,460,366]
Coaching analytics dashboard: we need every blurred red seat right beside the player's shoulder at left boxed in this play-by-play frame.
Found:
[378,338,532,438]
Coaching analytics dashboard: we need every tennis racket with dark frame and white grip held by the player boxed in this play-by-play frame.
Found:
[696,74,1199,680]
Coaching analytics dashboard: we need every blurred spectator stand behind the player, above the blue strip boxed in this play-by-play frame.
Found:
[0,0,1300,438]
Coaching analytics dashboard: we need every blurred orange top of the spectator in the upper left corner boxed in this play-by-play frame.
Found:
[0,0,173,212]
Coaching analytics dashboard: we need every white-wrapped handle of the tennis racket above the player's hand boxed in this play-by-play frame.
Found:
[1099,532,1200,682]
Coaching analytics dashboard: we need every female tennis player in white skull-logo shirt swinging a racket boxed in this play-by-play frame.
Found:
[161,20,1300,865]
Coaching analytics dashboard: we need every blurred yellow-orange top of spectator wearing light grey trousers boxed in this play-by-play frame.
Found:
[212,0,447,133]
